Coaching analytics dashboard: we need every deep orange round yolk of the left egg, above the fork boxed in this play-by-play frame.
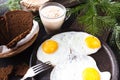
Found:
[42,40,58,54]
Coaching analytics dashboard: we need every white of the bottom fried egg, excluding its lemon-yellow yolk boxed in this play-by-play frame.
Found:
[50,56,111,80]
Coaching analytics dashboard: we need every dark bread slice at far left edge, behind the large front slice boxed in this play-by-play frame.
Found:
[0,16,9,45]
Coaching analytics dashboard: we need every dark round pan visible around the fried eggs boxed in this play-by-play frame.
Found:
[30,30,119,80]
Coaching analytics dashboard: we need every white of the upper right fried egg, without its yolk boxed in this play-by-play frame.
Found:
[51,31,101,55]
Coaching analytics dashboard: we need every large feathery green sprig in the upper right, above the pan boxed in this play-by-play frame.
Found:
[71,0,120,36]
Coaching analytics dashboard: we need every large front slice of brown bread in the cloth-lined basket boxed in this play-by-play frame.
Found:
[5,10,33,48]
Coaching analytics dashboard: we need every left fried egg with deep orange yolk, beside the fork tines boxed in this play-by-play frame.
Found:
[37,39,70,66]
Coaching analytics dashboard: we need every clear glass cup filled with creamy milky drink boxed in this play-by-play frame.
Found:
[39,2,66,34]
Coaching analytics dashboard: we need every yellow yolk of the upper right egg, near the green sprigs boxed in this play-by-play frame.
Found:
[85,36,101,49]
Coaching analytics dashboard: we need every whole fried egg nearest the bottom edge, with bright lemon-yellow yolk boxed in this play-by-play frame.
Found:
[50,56,111,80]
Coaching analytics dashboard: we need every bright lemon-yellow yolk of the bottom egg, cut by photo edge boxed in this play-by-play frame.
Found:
[82,68,100,80]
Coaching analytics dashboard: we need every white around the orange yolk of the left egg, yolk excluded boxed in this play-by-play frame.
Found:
[37,39,70,66]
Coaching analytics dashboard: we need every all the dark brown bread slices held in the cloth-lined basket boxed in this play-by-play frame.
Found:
[0,10,33,48]
